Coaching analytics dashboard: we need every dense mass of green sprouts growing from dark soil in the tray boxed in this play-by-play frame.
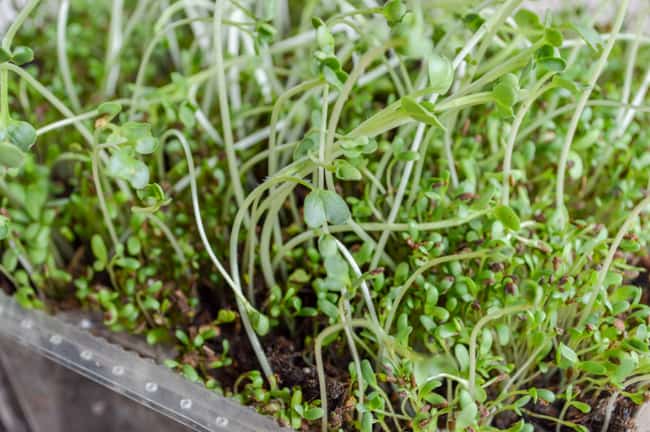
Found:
[0,0,650,432]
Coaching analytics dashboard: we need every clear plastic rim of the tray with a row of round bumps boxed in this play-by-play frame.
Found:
[0,292,281,432]
